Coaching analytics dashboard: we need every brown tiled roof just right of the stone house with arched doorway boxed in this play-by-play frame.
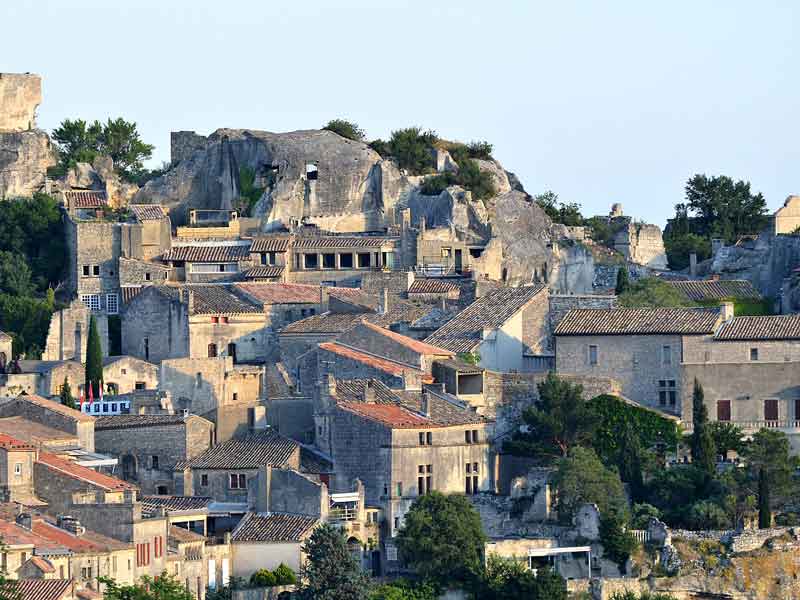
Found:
[176,429,300,469]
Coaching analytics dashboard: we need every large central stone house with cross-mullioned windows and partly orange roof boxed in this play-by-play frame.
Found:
[315,376,495,536]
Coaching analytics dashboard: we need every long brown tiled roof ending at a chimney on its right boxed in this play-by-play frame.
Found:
[555,308,720,335]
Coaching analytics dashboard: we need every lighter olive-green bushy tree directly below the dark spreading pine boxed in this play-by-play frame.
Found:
[553,446,628,522]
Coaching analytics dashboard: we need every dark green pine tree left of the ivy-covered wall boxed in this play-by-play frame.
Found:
[504,372,598,461]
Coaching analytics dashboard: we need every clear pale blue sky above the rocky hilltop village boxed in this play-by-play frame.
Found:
[0,0,800,226]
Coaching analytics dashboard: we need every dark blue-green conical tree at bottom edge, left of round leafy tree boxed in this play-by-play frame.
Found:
[298,524,370,600]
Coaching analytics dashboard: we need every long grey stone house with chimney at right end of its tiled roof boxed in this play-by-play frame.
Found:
[554,304,720,414]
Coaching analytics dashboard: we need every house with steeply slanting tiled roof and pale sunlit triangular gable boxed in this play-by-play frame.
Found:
[425,285,553,371]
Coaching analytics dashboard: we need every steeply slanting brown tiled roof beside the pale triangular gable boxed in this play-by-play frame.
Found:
[425,285,545,353]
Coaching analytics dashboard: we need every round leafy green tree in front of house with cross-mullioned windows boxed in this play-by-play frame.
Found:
[397,492,486,585]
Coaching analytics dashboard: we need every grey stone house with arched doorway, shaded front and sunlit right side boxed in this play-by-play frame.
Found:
[95,413,214,495]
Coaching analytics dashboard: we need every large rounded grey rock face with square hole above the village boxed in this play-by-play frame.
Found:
[136,129,407,231]
